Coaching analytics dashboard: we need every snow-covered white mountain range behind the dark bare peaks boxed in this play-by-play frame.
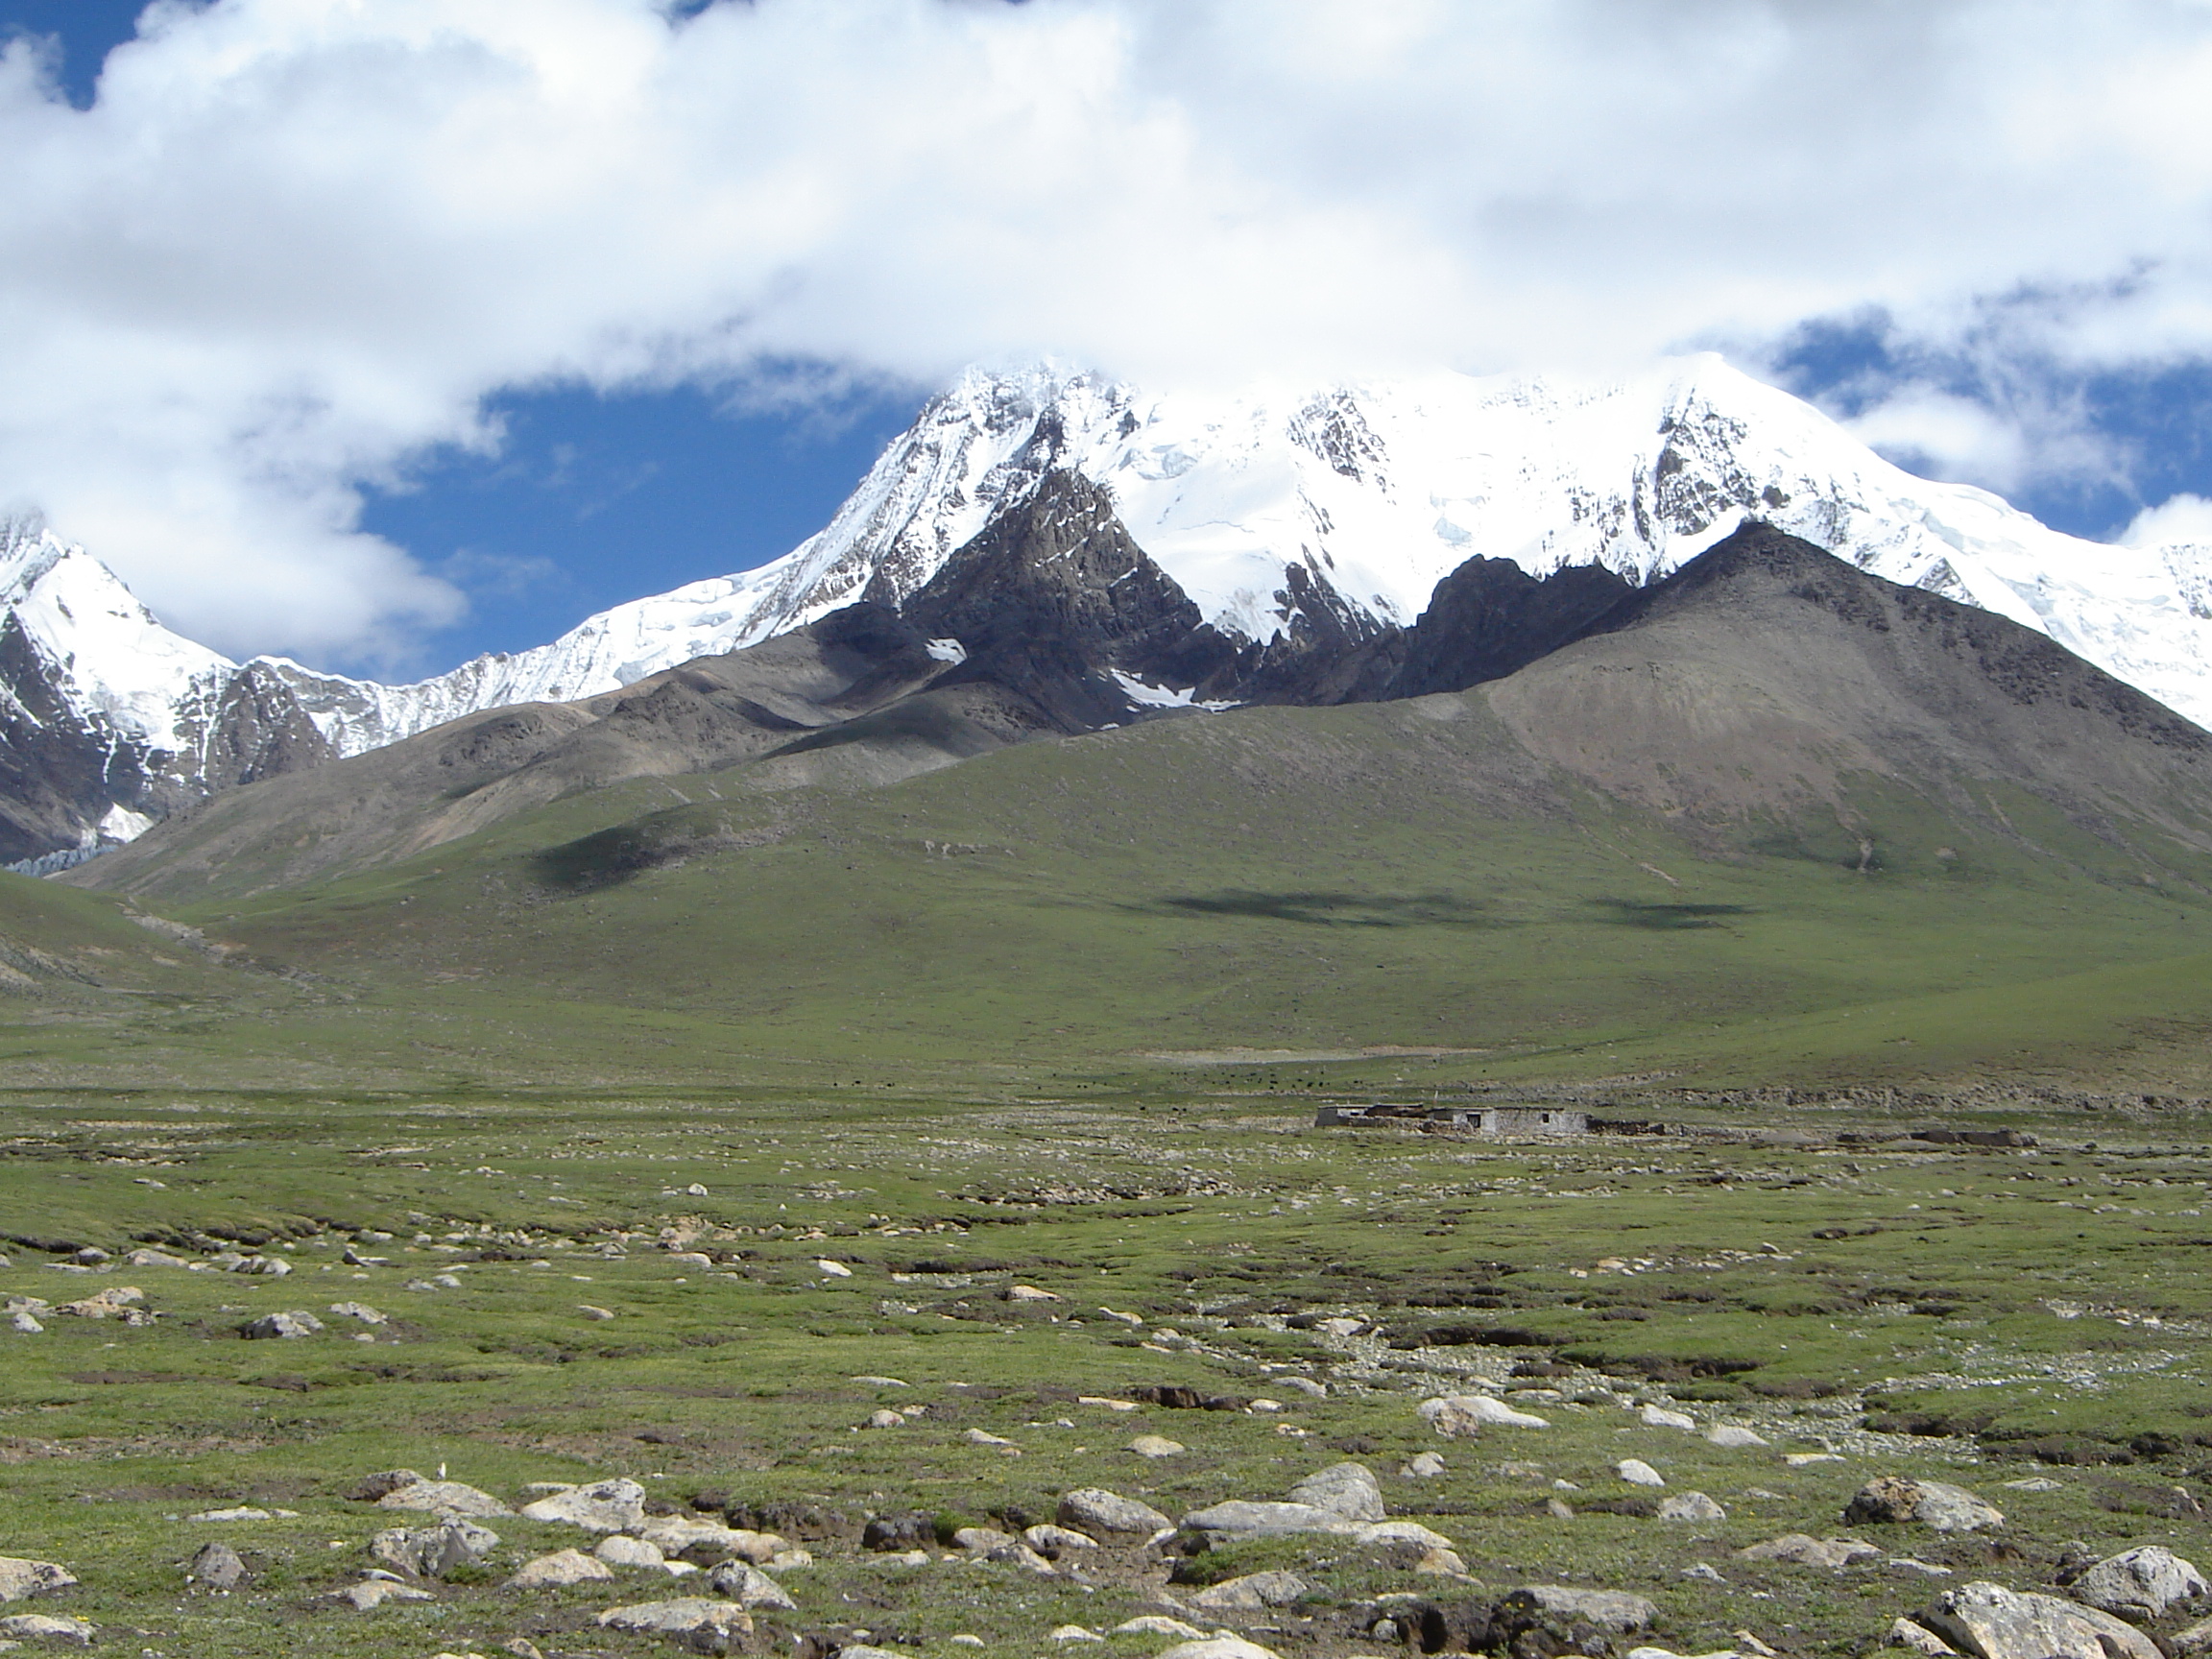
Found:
[0,356,2212,871]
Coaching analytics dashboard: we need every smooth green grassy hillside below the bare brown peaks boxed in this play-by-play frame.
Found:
[47,697,2212,1082]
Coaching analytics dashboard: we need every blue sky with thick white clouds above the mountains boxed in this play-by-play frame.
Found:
[0,0,2212,675]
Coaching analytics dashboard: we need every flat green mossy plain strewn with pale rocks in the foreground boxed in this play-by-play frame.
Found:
[0,1075,2212,1659]
